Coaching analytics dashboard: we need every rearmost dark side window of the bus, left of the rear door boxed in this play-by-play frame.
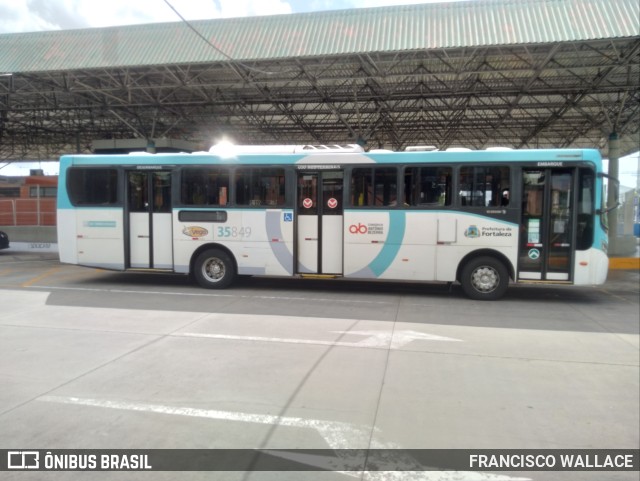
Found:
[67,167,118,206]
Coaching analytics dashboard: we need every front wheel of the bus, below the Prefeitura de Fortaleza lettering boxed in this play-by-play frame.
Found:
[460,257,509,301]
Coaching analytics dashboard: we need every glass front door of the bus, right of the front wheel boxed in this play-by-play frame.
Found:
[518,169,576,281]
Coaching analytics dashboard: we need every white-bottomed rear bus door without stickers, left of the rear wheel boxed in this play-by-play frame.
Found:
[127,171,173,269]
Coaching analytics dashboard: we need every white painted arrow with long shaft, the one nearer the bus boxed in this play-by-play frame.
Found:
[178,331,462,349]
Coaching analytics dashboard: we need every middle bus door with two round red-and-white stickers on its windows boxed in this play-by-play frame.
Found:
[296,171,343,275]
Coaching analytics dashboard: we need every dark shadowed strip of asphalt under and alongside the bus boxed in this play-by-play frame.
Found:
[37,271,638,334]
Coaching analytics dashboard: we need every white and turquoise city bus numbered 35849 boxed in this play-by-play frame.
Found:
[57,146,608,300]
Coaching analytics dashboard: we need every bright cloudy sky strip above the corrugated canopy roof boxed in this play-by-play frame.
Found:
[0,0,458,34]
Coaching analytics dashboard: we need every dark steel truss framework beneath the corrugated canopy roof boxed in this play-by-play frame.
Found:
[0,37,640,160]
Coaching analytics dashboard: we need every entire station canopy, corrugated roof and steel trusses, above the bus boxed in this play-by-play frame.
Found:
[0,0,640,161]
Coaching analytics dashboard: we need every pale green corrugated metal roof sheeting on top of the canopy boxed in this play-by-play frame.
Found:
[0,0,640,72]
